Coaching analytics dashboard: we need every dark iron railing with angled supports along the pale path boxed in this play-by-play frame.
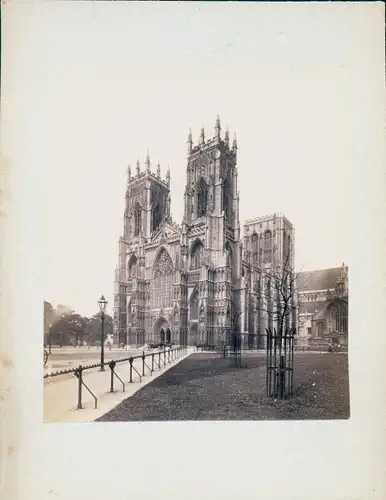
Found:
[44,346,187,410]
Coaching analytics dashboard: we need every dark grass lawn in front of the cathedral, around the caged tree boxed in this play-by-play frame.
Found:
[98,353,350,422]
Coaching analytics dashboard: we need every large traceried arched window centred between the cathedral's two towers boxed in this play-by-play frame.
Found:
[152,248,174,309]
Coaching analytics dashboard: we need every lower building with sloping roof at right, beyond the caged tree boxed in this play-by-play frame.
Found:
[297,263,348,347]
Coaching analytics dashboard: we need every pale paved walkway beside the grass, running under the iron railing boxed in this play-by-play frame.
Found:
[44,348,193,422]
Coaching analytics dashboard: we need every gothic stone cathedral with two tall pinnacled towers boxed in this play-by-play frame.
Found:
[113,117,296,347]
